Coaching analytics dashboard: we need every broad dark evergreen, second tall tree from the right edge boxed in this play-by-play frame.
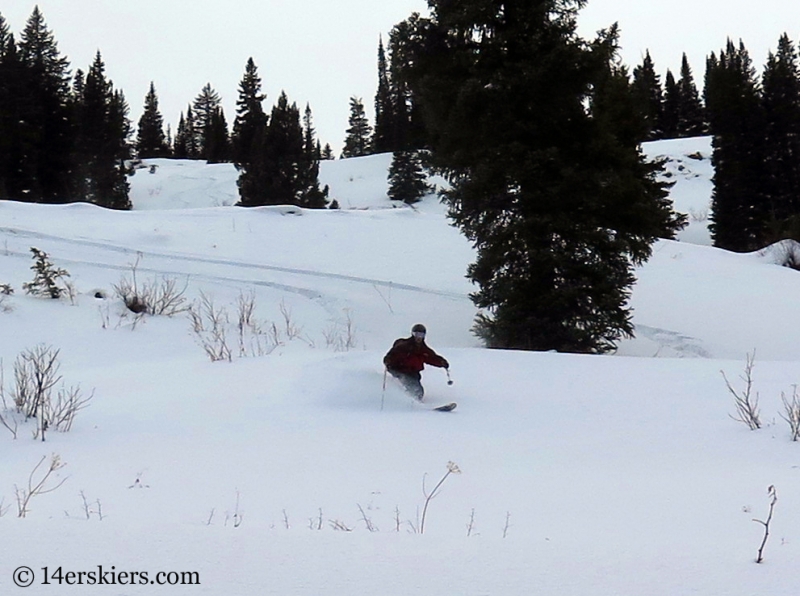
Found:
[705,40,767,251]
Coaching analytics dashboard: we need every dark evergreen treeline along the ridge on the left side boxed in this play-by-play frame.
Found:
[0,7,340,209]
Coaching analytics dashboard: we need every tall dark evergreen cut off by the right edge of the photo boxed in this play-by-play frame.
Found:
[762,33,800,242]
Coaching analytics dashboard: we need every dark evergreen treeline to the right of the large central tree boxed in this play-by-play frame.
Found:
[617,34,800,251]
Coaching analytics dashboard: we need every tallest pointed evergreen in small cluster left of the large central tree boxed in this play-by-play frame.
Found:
[231,58,267,168]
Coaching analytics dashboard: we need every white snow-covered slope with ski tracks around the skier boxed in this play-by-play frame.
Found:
[0,138,800,596]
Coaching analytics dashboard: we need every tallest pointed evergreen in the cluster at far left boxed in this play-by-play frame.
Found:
[18,7,72,203]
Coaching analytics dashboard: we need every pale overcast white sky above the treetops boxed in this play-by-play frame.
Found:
[0,0,800,152]
